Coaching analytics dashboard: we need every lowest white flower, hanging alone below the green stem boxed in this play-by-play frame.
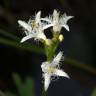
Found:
[41,52,69,91]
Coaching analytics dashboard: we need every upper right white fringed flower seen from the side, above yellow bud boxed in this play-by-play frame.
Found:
[41,10,73,32]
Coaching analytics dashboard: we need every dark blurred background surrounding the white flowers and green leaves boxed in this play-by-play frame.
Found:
[0,0,96,96]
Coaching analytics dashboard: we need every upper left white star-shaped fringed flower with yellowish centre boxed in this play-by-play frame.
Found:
[18,11,46,42]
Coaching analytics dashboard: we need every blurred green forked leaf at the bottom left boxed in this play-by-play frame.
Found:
[13,73,34,96]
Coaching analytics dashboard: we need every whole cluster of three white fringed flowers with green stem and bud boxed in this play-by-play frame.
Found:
[18,10,73,91]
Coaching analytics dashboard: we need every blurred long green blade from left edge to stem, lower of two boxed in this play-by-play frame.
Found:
[0,38,44,54]
